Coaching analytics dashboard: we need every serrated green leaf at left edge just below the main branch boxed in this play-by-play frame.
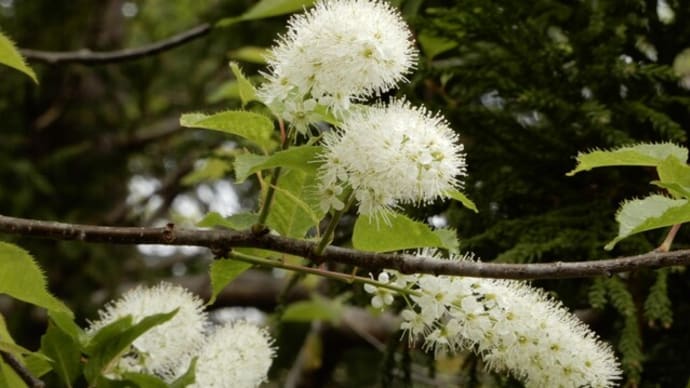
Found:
[0,242,72,316]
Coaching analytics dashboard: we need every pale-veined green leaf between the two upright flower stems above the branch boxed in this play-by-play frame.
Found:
[266,169,325,238]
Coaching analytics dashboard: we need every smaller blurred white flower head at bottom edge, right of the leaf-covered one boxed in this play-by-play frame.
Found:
[190,322,275,388]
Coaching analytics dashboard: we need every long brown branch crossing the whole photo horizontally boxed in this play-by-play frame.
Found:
[0,215,690,279]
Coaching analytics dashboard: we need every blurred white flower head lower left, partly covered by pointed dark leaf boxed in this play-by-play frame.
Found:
[87,283,206,380]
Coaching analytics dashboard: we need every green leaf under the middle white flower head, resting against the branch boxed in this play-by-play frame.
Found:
[352,213,444,252]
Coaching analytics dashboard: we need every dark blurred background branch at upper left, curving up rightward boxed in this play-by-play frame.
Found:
[20,23,212,65]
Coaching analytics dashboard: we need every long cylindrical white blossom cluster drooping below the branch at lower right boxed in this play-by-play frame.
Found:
[372,251,621,388]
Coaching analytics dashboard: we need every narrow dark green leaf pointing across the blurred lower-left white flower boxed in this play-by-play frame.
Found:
[84,309,177,383]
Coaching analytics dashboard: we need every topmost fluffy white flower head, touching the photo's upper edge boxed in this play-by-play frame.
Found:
[258,0,417,123]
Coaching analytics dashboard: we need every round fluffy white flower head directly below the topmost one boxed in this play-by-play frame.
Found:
[319,100,466,215]
